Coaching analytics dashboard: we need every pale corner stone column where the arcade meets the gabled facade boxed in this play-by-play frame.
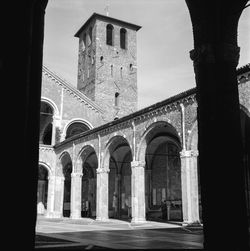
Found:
[53,176,65,218]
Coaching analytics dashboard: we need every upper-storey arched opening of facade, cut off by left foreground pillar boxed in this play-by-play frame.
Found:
[39,101,54,145]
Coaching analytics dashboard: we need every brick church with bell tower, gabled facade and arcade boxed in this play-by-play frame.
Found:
[37,13,250,225]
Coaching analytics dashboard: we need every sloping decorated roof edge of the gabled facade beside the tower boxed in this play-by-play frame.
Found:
[43,65,104,113]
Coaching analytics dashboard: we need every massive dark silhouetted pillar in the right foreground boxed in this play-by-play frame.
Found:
[186,0,250,250]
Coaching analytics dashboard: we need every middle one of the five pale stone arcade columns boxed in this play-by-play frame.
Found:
[96,168,109,221]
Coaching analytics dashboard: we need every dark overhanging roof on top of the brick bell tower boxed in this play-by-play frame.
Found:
[74,12,141,37]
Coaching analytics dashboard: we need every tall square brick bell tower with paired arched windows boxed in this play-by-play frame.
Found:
[75,13,141,121]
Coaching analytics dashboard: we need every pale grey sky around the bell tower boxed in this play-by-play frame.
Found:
[43,0,250,109]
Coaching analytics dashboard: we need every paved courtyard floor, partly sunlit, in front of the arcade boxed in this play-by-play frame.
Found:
[36,218,203,250]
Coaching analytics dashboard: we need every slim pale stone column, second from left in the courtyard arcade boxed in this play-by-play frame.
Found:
[70,173,82,219]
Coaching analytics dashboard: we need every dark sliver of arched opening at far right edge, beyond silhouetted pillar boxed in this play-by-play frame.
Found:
[240,109,250,226]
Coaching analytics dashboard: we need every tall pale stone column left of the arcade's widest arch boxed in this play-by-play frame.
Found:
[131,161,146,223]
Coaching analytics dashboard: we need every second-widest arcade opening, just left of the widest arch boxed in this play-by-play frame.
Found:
[108,136,132,220]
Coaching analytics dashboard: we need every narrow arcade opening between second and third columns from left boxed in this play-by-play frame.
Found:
[80,146,98,218]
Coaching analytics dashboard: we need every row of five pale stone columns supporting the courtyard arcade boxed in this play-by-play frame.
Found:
[42,150,200,225]
